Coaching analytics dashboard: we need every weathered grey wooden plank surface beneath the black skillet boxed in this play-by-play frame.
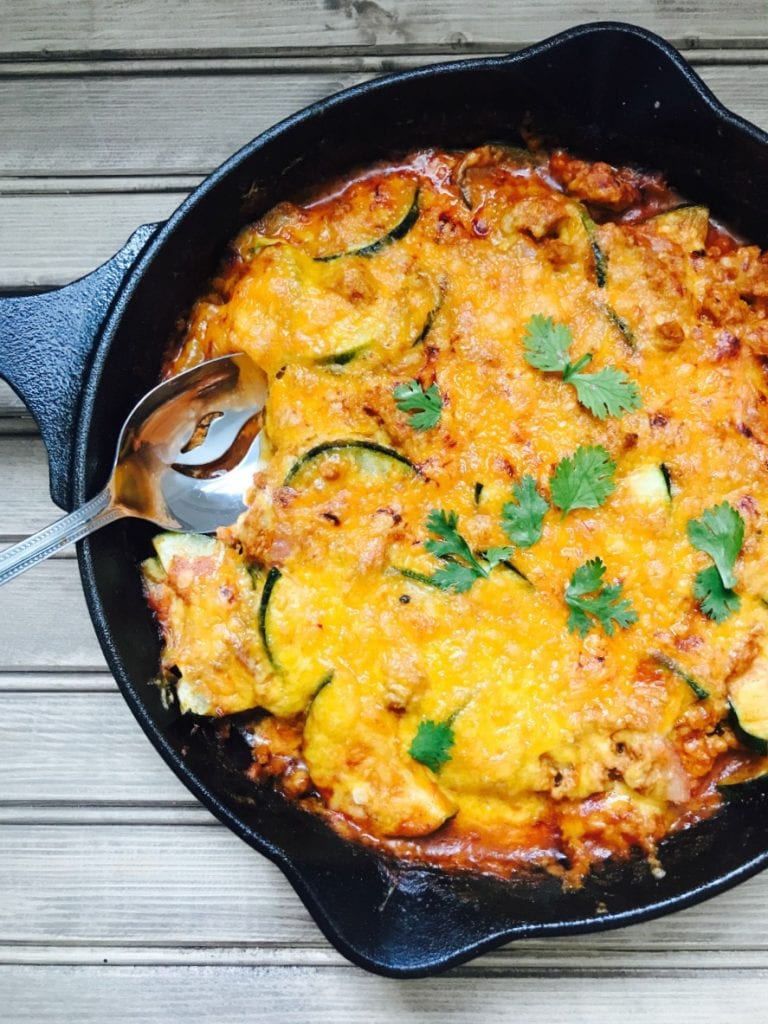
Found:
[0,0,768,1024]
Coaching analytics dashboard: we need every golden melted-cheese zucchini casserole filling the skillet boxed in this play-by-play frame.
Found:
[145,146,768,878]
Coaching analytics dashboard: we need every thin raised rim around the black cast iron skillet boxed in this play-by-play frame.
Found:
[72,22,768,978]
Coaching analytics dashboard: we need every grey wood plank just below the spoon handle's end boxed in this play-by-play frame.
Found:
[0,558,105,672]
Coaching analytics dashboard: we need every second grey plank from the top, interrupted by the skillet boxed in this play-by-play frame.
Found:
[0,65,768,177]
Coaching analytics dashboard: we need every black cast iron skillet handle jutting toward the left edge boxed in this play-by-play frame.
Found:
[0,224,160,509]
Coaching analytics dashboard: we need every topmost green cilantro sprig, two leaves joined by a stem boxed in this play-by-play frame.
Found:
[523,313,642,420]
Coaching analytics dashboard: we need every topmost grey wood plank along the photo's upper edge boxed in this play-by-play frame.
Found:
[2,0,767,56]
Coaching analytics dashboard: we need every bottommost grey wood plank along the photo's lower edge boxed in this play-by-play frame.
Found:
[0,966,768,1024]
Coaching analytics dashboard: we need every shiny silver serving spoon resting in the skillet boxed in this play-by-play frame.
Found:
[0,353,266,585]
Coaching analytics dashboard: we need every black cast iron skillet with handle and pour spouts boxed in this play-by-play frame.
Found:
[0,23,768,977]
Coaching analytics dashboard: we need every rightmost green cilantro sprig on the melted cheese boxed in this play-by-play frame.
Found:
[688,502,744,623]
